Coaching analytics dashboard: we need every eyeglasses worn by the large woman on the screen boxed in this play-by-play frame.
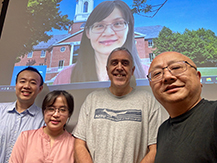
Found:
[90,20,128,34]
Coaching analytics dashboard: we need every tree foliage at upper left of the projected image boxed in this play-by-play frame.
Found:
[18,0,73,58]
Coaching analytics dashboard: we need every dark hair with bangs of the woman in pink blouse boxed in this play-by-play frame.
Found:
[42,90,74,118]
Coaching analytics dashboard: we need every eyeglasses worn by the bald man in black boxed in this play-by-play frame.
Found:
[147,61,197,82]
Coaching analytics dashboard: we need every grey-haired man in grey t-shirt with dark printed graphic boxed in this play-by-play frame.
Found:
[73,48,162,163]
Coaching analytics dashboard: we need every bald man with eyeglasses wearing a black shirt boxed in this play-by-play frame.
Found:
[148,52,217,163]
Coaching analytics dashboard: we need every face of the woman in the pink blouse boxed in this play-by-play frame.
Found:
[44,96,69,134]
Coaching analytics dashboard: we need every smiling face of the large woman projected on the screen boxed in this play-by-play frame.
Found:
[86,8,129,55]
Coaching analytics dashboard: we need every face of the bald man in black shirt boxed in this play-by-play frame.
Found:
[149,52,202,109]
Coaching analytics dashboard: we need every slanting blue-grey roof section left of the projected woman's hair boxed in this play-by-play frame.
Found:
[33,33,72,50]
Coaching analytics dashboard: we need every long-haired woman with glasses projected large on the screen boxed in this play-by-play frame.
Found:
[53,0,148,84]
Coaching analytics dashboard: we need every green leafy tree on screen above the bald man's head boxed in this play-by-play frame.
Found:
[153,27,217,67]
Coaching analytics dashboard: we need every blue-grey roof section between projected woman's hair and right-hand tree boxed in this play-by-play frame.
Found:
[134,25,163,39]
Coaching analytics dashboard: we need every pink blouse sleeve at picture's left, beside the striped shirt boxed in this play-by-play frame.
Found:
[9,132,27,163]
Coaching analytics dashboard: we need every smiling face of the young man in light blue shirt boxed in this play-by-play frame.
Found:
[15,70,43,106]
